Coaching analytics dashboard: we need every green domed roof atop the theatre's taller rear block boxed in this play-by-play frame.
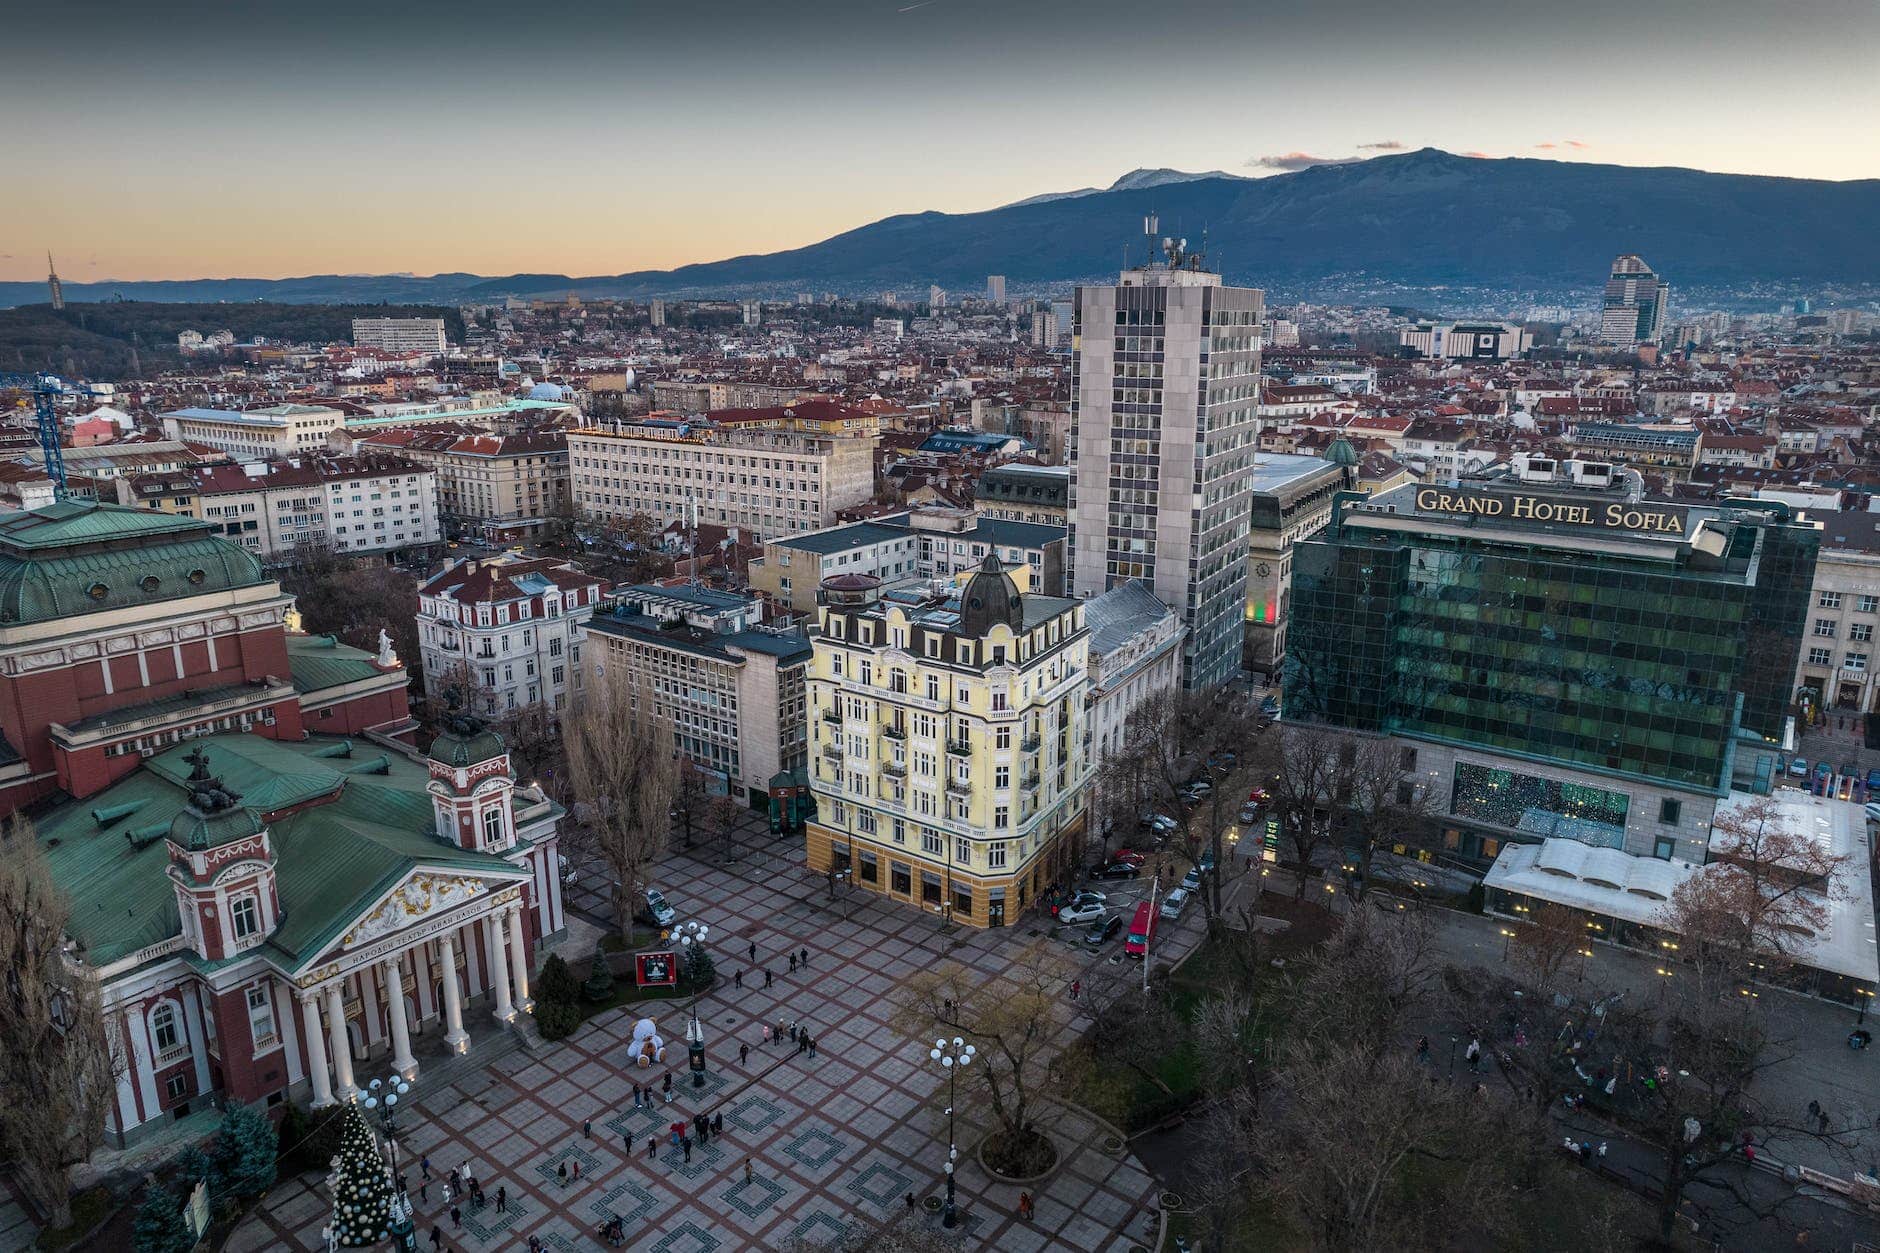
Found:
[0,500,267,623]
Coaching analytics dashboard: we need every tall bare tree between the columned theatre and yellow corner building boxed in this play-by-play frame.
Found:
[564,666,679,941]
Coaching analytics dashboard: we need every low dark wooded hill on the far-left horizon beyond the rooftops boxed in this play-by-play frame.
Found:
[0,301,464,378]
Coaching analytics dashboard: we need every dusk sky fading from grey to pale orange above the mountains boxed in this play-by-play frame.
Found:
[0,0,1880,282]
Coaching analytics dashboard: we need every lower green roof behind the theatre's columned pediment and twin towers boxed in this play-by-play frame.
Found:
[39,736,528,971]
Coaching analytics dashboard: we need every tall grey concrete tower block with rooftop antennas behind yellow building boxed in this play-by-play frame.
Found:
[1070,245,1265,689]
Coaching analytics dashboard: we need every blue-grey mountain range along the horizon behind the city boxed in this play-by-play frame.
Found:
[0,149,1880,305]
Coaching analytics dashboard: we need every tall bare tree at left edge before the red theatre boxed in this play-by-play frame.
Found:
[0,818,118,1229]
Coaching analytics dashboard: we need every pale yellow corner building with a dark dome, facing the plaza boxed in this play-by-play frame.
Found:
[807,555,1090,928]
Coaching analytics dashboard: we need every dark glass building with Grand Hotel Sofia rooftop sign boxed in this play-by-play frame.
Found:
[1284,457,1822,864]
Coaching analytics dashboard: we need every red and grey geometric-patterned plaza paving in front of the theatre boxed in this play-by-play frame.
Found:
[227,816,1201,1253]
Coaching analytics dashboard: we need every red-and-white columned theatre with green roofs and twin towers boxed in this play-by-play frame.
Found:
[0,502,566,1144]
